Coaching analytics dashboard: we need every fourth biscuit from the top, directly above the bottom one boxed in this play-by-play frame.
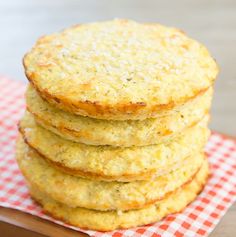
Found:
[17,139,204,211]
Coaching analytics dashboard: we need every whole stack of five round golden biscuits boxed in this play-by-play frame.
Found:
[17,19,218,231]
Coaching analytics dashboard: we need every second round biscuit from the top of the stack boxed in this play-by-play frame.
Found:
[26,86,213,147]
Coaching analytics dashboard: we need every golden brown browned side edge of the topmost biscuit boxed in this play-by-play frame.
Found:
[26,77,212,120]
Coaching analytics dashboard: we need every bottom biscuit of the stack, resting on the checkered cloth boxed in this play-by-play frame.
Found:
[28,161,208,231]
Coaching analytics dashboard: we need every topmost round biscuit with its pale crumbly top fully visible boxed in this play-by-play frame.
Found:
[23,20,218,120]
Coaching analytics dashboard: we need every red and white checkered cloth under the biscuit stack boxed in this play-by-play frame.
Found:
[0,77,236,237]
